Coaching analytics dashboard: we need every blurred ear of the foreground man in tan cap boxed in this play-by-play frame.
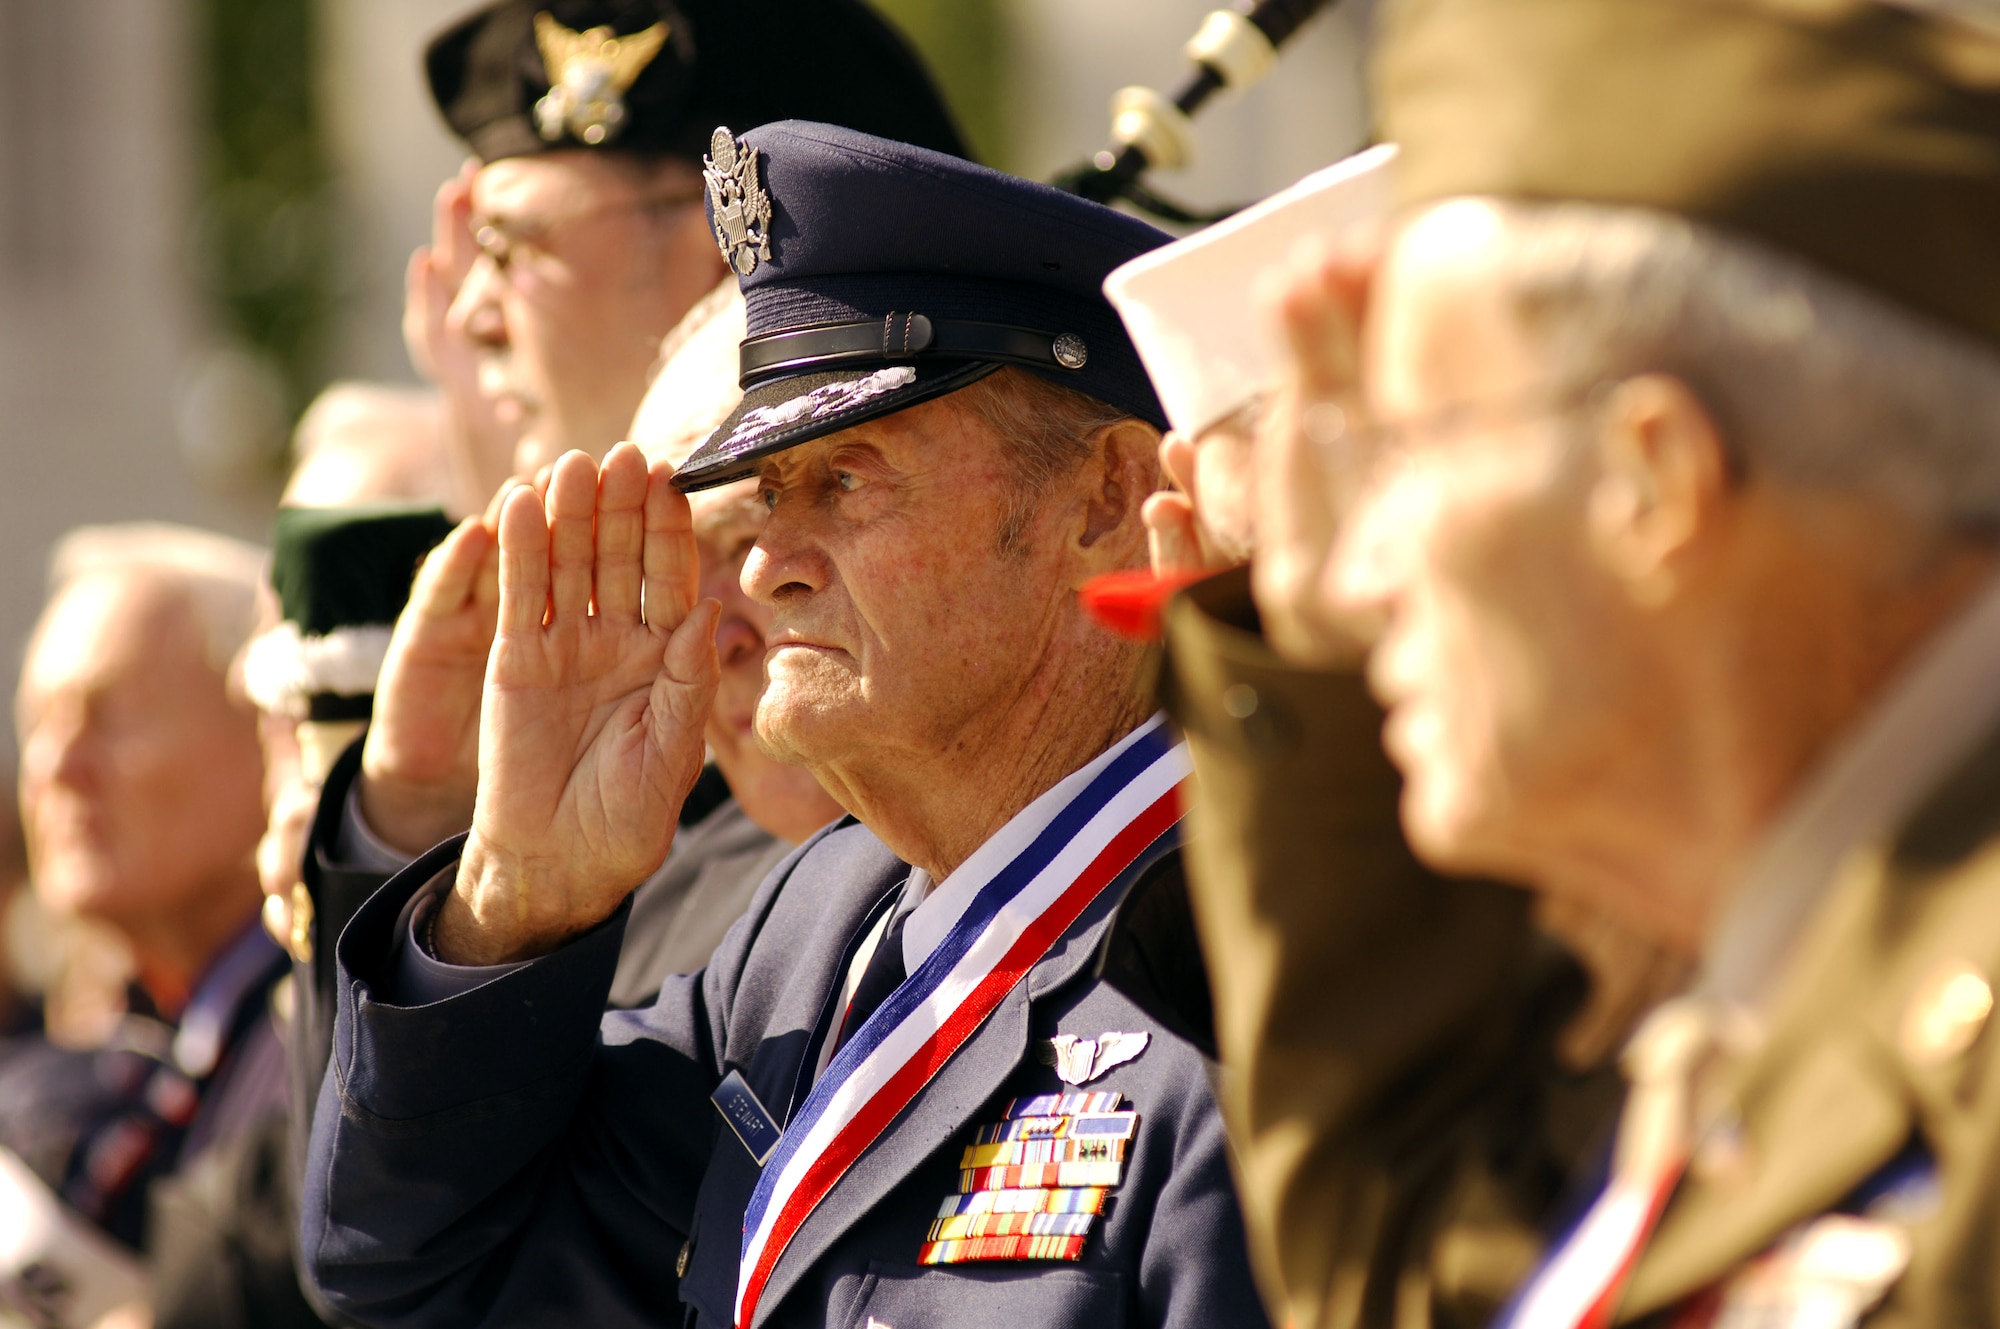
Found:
[1590,374,1730,606]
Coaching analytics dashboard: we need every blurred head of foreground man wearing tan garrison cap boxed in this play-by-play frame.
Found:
[1260,0,2000,955]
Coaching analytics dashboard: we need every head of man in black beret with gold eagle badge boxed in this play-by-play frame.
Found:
[426,0,962,488]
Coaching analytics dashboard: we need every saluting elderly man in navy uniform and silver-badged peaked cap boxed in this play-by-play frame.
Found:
[304,122,1264,1327]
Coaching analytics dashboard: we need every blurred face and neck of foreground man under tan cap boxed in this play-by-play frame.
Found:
[1272,200,1994,953]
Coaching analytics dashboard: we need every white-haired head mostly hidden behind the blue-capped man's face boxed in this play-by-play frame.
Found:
[632,278,842,845]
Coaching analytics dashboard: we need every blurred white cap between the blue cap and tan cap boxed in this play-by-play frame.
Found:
[1104,144,1396,436]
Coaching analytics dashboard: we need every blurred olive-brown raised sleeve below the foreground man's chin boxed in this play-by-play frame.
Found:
[1162,574,1614,1329]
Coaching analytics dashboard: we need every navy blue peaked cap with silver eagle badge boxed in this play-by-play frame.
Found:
[674,120,1170,490]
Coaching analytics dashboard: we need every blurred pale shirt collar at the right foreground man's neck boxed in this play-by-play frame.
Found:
[1694,580,2000,1011]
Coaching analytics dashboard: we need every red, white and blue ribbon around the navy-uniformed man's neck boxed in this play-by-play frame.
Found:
[736,719,1192,1327]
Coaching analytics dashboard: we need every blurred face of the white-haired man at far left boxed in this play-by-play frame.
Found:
[18,574,264,939]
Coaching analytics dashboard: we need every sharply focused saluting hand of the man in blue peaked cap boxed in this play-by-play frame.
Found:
[434,442,720,965]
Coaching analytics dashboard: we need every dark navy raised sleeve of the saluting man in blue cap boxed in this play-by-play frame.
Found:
[302,824,812,1325]
